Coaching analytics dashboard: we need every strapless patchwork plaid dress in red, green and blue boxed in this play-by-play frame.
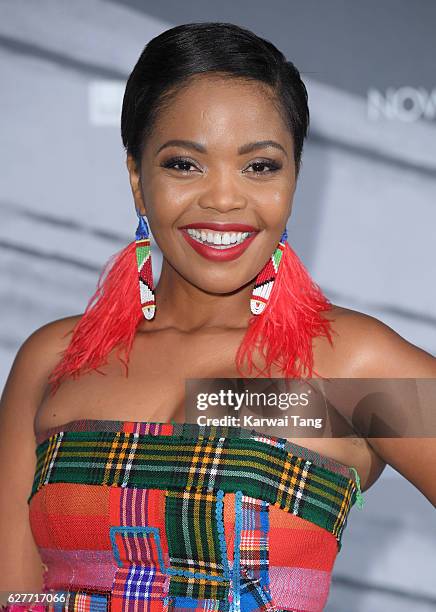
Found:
[27,419,362,612]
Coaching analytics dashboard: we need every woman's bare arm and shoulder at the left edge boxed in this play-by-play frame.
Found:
[0,317,80,593]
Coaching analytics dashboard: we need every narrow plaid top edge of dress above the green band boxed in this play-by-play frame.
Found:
[35,418,360,486]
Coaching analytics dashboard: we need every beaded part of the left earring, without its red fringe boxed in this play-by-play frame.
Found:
[135,207,156,321]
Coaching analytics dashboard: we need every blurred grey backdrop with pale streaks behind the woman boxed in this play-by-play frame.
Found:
[0,0,436,612]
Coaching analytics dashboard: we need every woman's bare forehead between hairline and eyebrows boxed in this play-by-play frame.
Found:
[148,75,291,146]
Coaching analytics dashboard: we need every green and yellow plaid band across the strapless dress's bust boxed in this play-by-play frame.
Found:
[27,431,357,549]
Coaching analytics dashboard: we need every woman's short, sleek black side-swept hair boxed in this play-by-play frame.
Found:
[121,21,309,176]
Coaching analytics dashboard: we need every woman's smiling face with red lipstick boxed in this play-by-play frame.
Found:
[128,75,296,294]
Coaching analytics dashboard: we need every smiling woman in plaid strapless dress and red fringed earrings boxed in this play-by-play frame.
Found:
[0,23,436,611]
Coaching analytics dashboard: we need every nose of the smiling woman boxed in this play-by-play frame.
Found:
[198,172,247,213]
